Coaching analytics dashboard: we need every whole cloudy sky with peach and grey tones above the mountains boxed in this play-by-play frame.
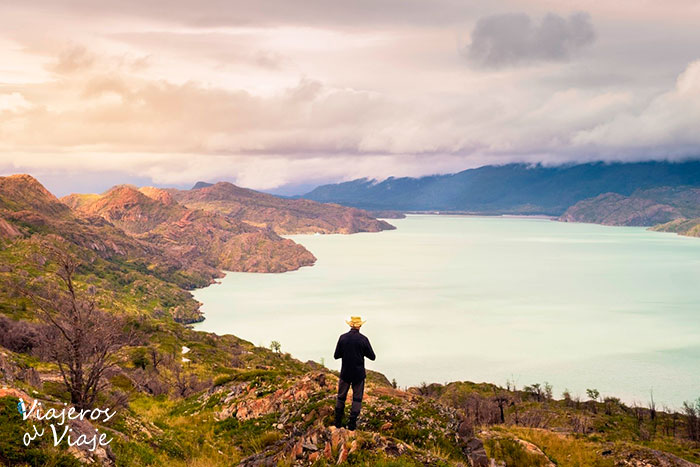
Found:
[0,0,700,194]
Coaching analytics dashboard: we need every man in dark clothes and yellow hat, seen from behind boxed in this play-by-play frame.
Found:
[333,316,376,431]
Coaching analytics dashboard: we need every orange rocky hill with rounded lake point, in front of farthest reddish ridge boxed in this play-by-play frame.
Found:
[63,185,315,272]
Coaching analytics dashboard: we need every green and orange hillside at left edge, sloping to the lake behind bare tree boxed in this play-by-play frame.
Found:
[0,175,213,322]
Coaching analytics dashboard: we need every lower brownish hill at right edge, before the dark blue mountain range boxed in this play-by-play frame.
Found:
[559,187,700,226]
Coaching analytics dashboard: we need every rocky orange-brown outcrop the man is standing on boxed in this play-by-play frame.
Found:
[208,370,470,466]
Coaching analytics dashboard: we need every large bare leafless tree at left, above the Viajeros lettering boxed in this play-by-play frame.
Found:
[21,252,131,409]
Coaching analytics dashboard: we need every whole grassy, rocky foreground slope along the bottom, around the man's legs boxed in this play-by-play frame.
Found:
[0,317,700,467]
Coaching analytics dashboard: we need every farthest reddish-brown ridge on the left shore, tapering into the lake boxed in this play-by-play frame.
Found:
[168,182,394,235]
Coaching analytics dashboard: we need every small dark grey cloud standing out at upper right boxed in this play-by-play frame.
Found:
[464,13,595,68]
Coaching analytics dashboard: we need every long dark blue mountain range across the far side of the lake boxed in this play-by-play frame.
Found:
[303,161,700,216]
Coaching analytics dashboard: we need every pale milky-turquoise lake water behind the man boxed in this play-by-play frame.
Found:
[195,215,700,407]
